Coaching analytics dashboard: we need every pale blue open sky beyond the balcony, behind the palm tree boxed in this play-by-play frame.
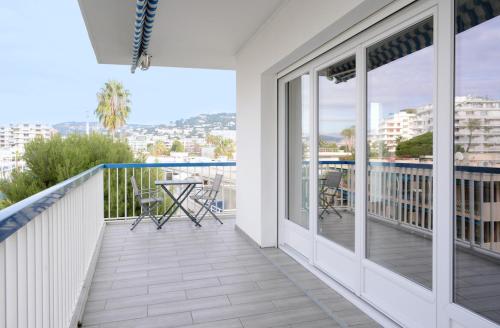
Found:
[0,0,236,125]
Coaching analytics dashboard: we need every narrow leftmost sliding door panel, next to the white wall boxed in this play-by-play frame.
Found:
[278,70,312,258]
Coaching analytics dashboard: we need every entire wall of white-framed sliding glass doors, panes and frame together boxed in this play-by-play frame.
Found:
[279,0,500,328]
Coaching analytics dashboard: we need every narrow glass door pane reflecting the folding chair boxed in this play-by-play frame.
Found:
[318,55,356,251]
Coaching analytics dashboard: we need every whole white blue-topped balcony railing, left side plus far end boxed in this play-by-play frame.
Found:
[0,162,236,328]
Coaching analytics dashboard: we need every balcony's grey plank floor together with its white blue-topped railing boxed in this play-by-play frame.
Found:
[0,162,379,327]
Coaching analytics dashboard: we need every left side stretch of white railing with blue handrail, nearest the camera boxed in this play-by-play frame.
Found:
[0,167,104,328]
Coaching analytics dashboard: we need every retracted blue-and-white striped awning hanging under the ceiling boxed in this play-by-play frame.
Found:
[131,0,159,73]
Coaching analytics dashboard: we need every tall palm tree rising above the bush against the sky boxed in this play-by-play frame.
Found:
[95,80,130,139]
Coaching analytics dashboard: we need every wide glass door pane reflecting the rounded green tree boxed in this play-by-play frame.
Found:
[366,18,434,289]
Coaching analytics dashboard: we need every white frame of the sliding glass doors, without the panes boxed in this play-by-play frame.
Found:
[276,0,497,328]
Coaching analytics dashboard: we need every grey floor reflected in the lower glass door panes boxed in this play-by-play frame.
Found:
[319,210,500,322]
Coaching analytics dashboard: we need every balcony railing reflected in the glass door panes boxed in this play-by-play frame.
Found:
[319,161,500,257]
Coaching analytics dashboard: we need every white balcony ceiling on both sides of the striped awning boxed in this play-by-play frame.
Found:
[79,0,284,69]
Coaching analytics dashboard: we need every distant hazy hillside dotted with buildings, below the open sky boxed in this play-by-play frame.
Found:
[53,113,236,136]
